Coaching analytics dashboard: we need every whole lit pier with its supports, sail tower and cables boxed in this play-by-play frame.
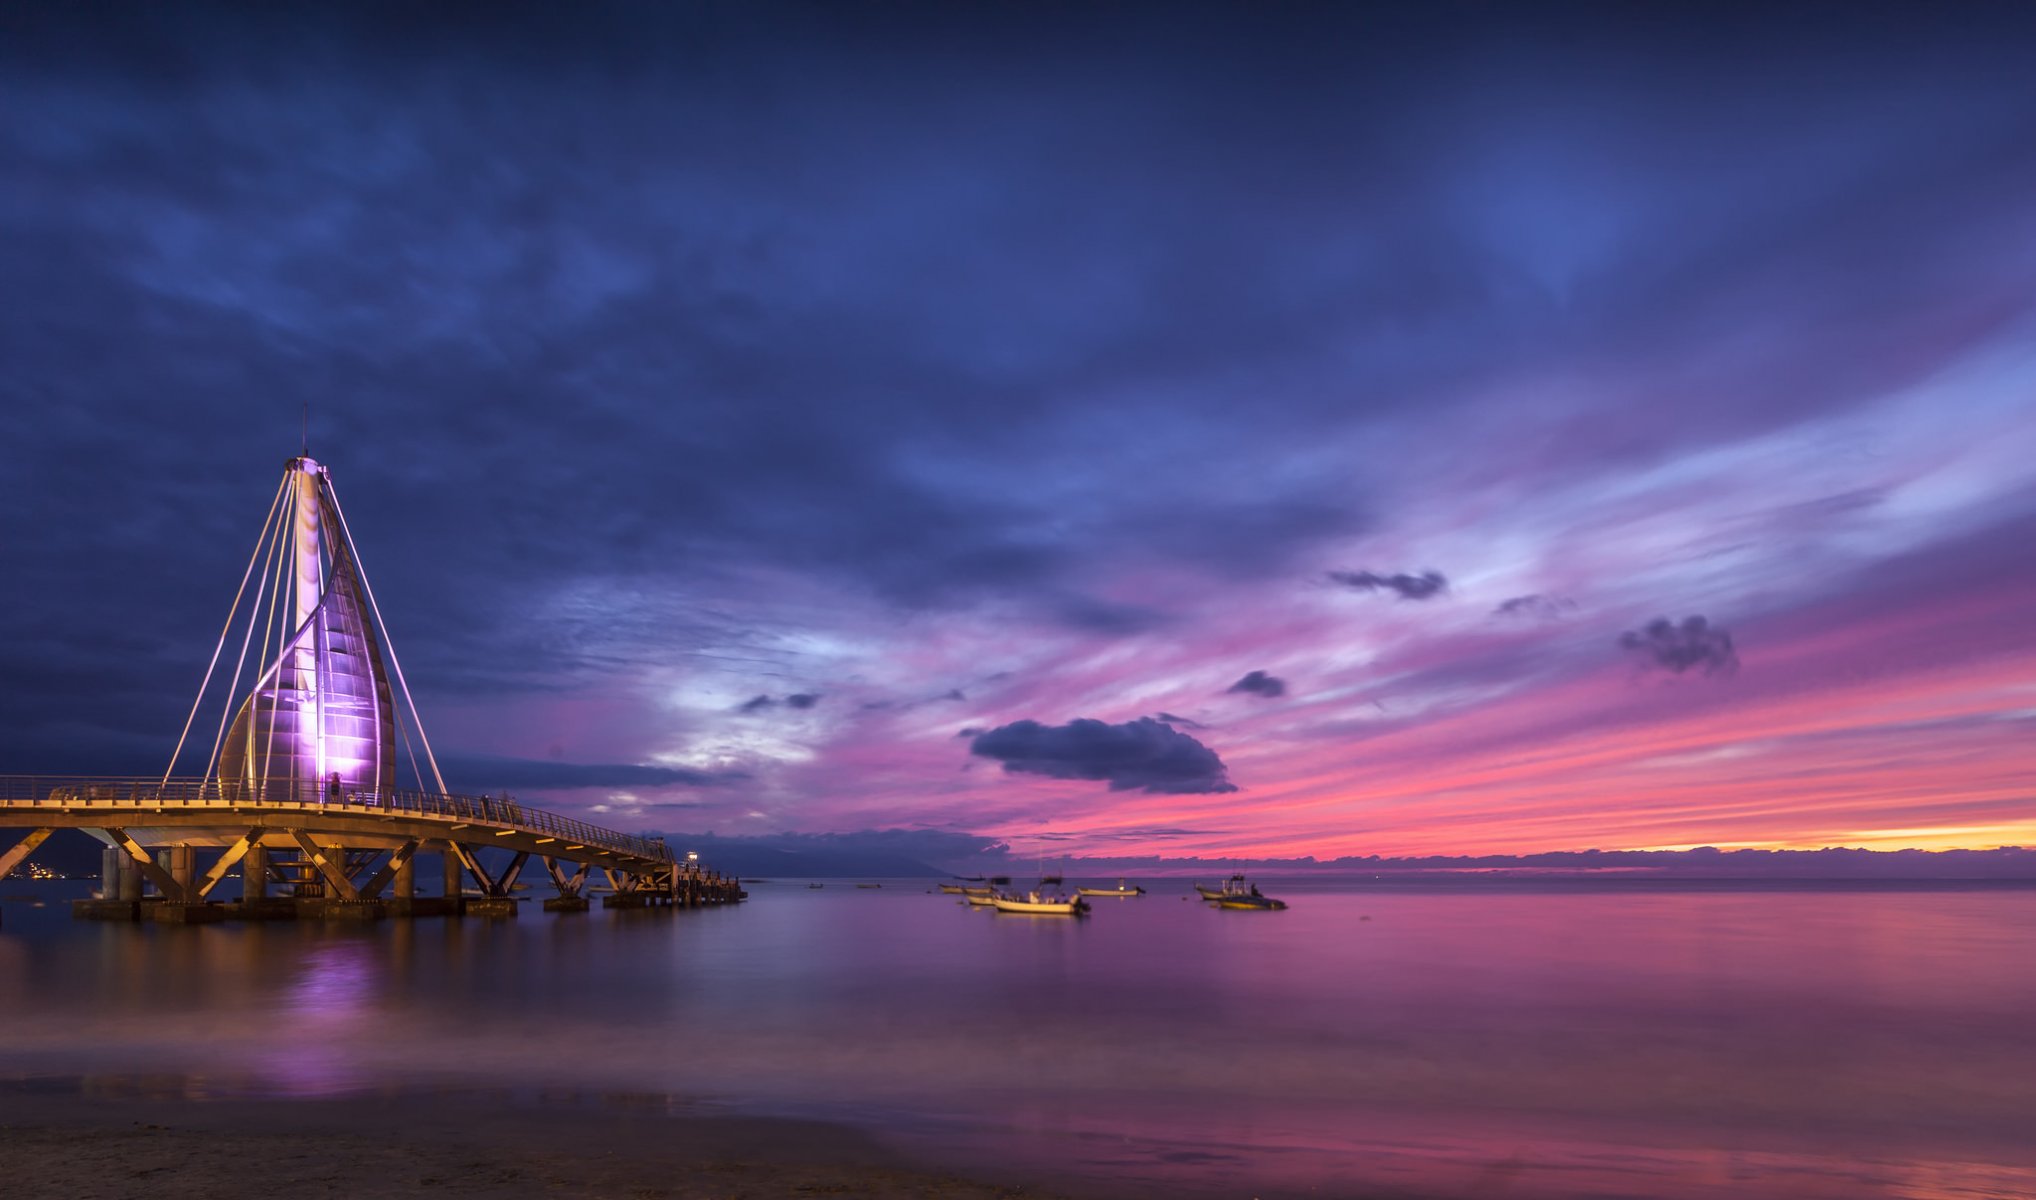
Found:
[0,454,743,923]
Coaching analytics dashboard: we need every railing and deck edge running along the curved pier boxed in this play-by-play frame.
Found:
[0,774,674,864]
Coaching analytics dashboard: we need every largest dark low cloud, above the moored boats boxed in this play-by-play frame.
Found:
[969,717,1238,795]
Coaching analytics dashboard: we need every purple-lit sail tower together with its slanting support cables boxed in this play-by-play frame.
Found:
[165,456,444,803]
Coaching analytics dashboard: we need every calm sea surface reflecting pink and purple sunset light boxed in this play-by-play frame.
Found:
[0,880,2036,1198]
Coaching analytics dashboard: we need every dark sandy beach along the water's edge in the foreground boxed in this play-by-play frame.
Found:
[0,1090,1051,1200]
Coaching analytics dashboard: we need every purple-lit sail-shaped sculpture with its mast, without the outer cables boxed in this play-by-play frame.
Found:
[216,456,395,803]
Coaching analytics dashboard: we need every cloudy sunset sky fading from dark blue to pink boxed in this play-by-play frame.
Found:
[0,4,2036,858]
